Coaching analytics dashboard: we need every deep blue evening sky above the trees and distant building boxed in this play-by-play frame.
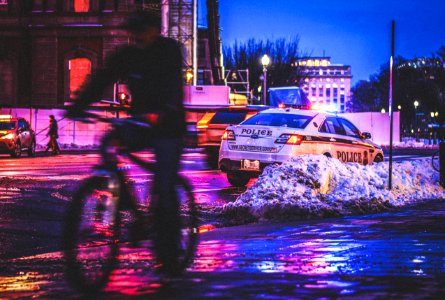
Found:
[198,0,445,84]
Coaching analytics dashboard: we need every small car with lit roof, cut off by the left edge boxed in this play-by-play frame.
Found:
[0,115,36,157]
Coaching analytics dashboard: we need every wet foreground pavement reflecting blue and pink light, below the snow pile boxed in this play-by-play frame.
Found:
[0,201,445,299]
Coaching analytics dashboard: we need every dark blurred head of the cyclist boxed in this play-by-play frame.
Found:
[122,11,161,47]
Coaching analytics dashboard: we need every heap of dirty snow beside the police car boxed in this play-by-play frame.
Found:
[223,155,445,220]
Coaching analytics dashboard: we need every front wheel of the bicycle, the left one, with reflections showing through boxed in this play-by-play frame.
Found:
[63,172,121,292]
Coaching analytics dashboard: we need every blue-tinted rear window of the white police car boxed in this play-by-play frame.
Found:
[241,113,313,128]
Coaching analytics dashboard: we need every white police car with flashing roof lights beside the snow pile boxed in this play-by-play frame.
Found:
[219,108,383,186]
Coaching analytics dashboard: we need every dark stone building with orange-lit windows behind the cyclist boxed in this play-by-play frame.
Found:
[0,0,145,107]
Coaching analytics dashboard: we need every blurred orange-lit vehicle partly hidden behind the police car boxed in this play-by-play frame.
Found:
[196,105,267,168]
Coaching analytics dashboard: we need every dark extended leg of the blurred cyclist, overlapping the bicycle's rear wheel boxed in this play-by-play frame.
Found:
[152,138,182,273]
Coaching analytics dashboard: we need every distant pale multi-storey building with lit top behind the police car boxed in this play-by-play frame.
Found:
[295,57,352,112]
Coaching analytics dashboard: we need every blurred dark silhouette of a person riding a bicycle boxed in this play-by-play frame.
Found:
[67,11,186,275]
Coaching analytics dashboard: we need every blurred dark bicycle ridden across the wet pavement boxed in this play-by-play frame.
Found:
[62,113,199,292]
